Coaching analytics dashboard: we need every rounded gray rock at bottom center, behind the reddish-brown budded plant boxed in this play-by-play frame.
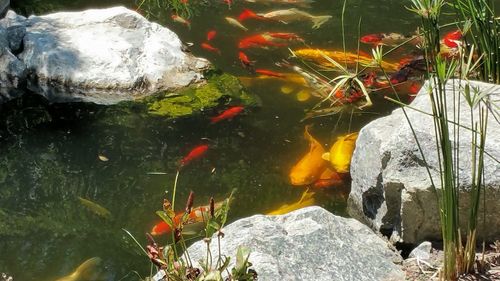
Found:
[188,207,404,281]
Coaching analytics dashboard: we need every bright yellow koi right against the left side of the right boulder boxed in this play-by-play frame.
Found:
[323,133,358,173]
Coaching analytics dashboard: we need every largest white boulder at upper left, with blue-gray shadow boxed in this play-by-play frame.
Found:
[18,7,209,104]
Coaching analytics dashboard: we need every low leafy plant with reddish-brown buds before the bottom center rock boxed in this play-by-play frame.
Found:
[120,168,257,281]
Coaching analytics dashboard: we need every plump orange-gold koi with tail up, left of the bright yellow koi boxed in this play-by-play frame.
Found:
[289,126,328,185]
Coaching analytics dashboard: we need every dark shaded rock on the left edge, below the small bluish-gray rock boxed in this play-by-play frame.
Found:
[0,26,27,102]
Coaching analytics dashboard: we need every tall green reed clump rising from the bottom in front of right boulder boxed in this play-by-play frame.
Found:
[404,0,498,280]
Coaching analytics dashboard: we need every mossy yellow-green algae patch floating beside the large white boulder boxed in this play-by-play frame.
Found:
[144,74,260,118]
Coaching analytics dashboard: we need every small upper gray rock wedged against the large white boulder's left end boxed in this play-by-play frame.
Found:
[0,10,26,54]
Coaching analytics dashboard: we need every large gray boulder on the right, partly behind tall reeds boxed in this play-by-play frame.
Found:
[348,81,500,243]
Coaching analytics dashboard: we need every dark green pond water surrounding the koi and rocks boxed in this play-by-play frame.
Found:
[0,0,430,280]
